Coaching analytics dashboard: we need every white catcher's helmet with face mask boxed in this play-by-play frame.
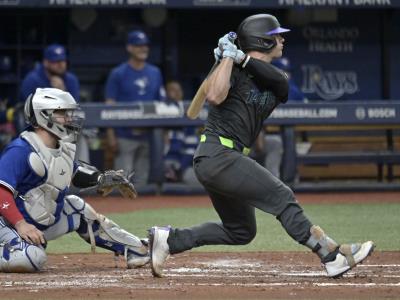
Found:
[24,88,84,142]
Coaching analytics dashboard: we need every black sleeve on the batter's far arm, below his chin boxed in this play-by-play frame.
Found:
[241,57,289,102]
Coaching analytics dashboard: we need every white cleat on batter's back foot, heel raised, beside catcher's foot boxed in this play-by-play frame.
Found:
[149,226,171,277]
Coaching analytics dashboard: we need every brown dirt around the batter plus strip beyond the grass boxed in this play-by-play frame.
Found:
[0,193,400,300]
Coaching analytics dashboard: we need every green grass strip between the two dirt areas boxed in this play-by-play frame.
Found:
[48,203,400,253]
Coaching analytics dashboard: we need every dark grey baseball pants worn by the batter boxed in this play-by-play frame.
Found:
[168,136,312,254]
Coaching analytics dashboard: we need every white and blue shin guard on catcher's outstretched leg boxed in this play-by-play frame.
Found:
[68,196,150,268]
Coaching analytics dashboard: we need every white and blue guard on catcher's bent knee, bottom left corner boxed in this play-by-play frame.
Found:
[0,237,47,273]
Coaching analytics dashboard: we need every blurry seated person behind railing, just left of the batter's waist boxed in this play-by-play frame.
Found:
[164,80,201,187]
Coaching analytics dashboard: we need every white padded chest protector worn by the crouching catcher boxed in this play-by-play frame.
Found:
[20,131,76,226]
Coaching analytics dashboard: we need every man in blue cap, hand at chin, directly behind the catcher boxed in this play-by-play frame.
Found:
[20,44,90,163]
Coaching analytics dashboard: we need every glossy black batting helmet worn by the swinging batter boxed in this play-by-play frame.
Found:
[237,14,290,52]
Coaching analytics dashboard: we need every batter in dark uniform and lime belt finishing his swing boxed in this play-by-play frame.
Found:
[149,14,374,277]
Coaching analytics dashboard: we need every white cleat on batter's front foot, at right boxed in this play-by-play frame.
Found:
[324,241,375,278]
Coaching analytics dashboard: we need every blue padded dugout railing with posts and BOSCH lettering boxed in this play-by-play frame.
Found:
[82,101,400,193]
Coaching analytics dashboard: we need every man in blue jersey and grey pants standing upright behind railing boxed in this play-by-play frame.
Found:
[105,30,165,185]
